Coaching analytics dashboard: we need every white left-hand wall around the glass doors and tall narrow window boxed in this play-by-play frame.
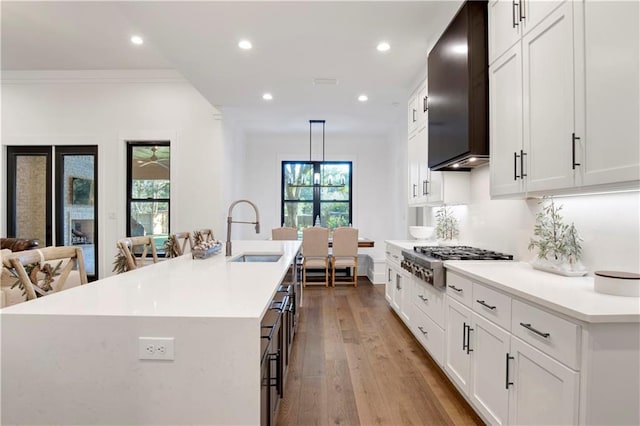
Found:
[0,71,226,277]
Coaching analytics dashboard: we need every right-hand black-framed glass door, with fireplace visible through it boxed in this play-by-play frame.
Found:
[55,146,98,281]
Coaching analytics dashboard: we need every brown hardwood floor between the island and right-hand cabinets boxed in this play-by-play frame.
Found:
[277,277,483,426]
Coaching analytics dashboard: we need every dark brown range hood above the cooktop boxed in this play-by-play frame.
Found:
[428,1,489,170]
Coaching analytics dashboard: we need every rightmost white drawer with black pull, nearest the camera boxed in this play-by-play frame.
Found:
[511,300,581,370]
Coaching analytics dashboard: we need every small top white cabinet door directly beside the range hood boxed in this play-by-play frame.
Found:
[488,0,521,65]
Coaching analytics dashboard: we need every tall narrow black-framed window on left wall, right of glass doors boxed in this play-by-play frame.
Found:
[127,141,170,255]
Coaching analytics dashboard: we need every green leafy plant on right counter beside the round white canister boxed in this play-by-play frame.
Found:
[529,198,582,264]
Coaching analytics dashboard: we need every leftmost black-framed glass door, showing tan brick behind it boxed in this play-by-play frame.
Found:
[7,146,52,247]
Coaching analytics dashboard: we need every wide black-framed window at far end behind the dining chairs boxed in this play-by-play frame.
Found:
[281,161,352,230]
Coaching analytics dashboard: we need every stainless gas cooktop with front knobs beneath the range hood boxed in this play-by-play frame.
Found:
[400,246,513,288]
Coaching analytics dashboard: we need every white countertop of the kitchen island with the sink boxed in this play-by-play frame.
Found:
[0,240,301,318]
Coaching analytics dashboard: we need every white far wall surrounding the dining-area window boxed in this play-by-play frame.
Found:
[232,130,406,257]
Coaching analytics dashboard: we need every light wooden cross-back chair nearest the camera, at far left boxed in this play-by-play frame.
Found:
[2,246,88,300]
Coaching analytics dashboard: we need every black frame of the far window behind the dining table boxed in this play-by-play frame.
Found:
[280,160,353,230]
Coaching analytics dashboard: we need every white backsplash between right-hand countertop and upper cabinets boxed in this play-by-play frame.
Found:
[424,166,640,274]
